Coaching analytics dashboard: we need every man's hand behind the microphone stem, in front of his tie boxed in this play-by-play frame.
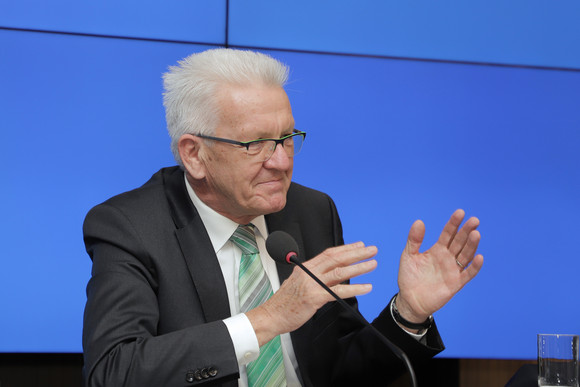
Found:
[246,242,377,346]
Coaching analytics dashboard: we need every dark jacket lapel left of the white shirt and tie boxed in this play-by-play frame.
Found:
[163,167,231,321]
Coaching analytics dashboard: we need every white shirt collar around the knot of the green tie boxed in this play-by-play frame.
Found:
[183,173,268,253]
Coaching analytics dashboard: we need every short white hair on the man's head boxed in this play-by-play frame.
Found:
[163,48,288,167]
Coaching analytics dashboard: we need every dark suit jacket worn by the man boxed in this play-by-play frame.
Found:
[83,167,443,387]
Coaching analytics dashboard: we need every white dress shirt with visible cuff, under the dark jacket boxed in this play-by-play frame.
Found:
[184,174,301,387]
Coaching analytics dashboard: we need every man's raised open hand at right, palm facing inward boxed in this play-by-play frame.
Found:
[397,210,483,316]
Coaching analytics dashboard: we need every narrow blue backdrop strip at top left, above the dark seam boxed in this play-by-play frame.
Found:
[0,0,226,44]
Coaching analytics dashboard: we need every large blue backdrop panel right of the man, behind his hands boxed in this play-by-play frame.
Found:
[273,52,580,359]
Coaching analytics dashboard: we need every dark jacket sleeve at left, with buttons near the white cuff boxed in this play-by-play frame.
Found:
[83,204,239,387]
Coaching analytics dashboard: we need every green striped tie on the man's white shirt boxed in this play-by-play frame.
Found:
[230,224,286,387]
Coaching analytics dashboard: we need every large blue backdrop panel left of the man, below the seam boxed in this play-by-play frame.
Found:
[0,31,213,352]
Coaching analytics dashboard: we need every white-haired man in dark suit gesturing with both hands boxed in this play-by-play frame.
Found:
[83,49,483,387]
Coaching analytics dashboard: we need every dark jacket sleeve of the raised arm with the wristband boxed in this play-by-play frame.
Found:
[294,189,444,387]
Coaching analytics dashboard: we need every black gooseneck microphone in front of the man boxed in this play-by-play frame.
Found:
[266,231,417,387]
